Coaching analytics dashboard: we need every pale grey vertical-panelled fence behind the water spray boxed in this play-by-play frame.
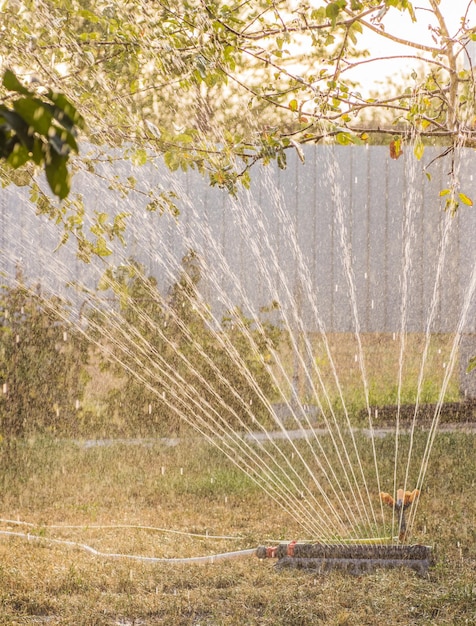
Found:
[0,146,476,333]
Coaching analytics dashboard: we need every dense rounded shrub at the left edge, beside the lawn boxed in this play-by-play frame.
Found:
[0,274,88,441]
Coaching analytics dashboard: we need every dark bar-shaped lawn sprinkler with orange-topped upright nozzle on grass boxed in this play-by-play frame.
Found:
[256,489,434,576]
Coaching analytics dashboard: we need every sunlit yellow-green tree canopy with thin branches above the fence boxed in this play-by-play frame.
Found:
[0,0,476,204]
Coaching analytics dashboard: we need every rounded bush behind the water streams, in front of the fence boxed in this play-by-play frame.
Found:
[90,252,280,434]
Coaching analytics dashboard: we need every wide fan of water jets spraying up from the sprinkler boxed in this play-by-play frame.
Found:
[1,148,476,573]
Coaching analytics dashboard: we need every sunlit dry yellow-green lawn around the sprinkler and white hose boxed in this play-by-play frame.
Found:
[0,433,476,626]
